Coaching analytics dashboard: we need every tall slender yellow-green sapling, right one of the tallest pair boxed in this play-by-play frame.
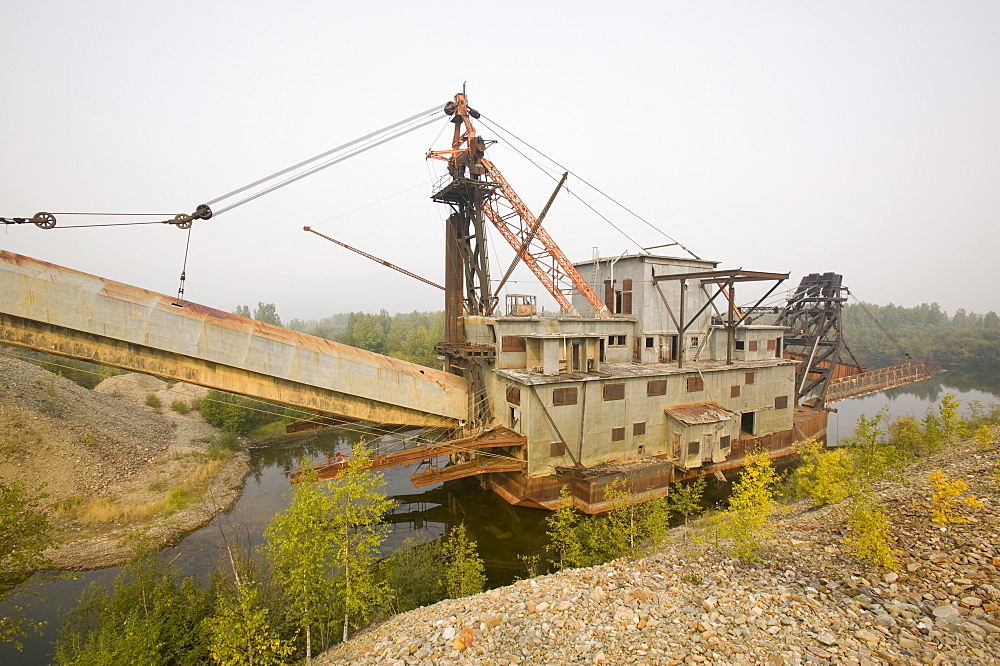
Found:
[327,444,393,641]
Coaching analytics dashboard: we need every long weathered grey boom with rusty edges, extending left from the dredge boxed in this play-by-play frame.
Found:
[0,251,468,427]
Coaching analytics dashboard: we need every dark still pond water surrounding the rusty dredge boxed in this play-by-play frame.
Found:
[0,374,1000,666]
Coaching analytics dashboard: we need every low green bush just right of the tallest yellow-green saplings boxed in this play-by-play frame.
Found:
[386,538,448,613]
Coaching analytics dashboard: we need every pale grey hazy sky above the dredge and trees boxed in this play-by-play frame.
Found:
[0,0,1000,321]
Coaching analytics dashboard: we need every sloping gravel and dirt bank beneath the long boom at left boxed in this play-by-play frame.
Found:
[0,356,249,569]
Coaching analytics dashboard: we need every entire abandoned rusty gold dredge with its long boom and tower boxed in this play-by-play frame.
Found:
[0,92,931,513]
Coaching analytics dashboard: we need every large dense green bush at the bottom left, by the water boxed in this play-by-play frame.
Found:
[55,555,210,666]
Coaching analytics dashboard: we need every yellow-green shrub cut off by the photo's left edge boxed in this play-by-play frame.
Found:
[0,482,52,650]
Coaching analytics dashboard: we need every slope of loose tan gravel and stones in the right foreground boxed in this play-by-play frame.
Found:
[316,428,1000,666]
